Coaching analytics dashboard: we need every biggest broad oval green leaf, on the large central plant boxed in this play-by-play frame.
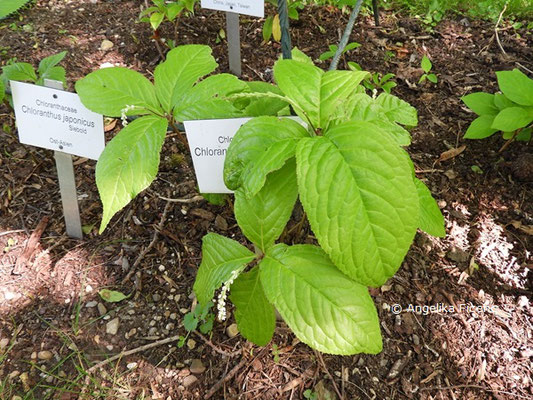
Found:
[296,122,419,286]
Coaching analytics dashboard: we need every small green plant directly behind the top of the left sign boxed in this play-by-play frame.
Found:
[0,51,67,104]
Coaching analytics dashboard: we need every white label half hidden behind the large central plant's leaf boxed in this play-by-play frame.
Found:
[183,118,251,193]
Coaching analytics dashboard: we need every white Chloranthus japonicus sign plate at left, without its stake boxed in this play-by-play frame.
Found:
[11,81,105,160]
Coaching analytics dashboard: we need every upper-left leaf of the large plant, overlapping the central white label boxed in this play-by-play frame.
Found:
[224,117,308,191]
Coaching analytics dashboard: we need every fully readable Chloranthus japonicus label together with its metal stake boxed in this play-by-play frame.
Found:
[11,80,105,239]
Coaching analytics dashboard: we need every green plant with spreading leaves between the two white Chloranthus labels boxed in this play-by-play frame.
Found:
[76,45,286,233]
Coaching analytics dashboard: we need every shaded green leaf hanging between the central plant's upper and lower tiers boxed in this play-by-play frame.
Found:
[234,159,298,252]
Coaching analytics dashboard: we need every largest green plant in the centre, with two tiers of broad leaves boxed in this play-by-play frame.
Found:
[194,54,445,354]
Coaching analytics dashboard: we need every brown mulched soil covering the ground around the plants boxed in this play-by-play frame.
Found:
[0,0,533,400]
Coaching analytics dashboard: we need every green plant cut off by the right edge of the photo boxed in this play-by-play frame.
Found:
[461,69,533,141]
